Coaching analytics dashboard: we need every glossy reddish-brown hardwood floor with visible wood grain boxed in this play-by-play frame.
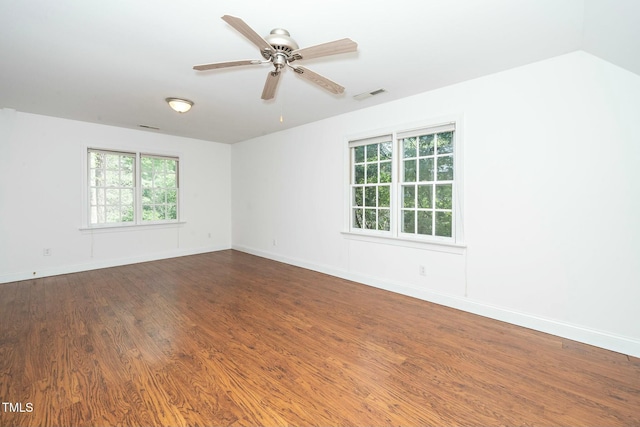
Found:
[0,251,640,426]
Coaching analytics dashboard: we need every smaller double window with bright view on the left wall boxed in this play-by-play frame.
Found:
[87,149,179,226]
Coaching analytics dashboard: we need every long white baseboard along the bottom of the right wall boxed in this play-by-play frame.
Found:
[232,245,640,357]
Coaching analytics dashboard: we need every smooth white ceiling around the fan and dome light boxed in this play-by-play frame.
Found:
[0,0,640,143]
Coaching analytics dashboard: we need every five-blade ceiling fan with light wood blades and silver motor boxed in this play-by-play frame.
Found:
[193,15,358,100]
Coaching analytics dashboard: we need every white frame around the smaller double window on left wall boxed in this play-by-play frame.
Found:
[80,145,184,231]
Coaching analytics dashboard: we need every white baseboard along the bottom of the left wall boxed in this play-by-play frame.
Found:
[0,246,231,284]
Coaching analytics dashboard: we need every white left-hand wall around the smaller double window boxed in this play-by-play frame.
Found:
[0,109,231,283]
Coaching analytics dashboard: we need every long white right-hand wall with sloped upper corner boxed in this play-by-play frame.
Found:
[231,52,640,356]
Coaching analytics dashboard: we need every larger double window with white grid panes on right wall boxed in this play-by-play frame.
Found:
[349,123,458,242]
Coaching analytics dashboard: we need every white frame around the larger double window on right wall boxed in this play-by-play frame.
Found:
[342,115,466,252]
